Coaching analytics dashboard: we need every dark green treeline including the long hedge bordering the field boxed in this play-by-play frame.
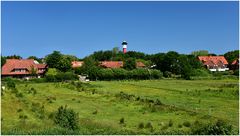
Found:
[1,47,239,81]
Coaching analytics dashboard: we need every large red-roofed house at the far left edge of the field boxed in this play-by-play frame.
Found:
[2,59,47,79]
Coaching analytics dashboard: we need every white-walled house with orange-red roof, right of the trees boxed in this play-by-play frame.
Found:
[198,56,229,71]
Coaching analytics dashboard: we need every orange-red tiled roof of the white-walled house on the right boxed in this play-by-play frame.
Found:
[198,56,228,65]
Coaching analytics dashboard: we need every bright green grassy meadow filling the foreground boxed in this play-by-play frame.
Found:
[1,79,239,134]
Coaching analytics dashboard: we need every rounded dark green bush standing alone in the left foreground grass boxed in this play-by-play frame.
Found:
[54,106,79,130]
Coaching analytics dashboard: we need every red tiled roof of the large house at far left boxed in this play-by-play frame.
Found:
[2,59,47,75]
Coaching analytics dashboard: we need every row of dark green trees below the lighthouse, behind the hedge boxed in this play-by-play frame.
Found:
[1,48,239,79]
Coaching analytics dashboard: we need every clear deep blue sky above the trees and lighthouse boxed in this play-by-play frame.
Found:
[1,1,239,58]
